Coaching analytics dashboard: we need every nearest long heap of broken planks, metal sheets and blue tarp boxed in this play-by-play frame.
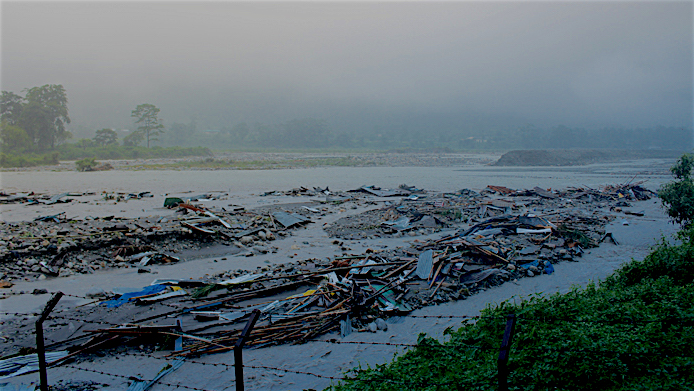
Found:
[0,216,604,356]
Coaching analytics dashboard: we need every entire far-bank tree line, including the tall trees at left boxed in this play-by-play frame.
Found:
[0,84,693,153]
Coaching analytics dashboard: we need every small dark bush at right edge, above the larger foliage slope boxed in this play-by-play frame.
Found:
[658,153,694,227]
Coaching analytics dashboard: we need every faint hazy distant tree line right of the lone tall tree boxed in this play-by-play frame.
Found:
[161,118,693,151]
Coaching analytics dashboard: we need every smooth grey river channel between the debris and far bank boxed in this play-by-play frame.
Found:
[0,159,674,195]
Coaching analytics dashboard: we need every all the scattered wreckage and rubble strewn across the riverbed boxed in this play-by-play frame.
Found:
[0,183,654,366]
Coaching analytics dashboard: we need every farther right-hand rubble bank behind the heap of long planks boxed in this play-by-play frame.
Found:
[325,182,655,244]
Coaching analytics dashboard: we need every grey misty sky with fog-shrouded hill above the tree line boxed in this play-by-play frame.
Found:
[0,1,693,133]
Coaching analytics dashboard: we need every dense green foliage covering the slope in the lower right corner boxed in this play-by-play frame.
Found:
[330,234,694,391]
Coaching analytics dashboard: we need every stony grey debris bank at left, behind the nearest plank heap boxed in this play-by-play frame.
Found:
[0,203,320,280]
